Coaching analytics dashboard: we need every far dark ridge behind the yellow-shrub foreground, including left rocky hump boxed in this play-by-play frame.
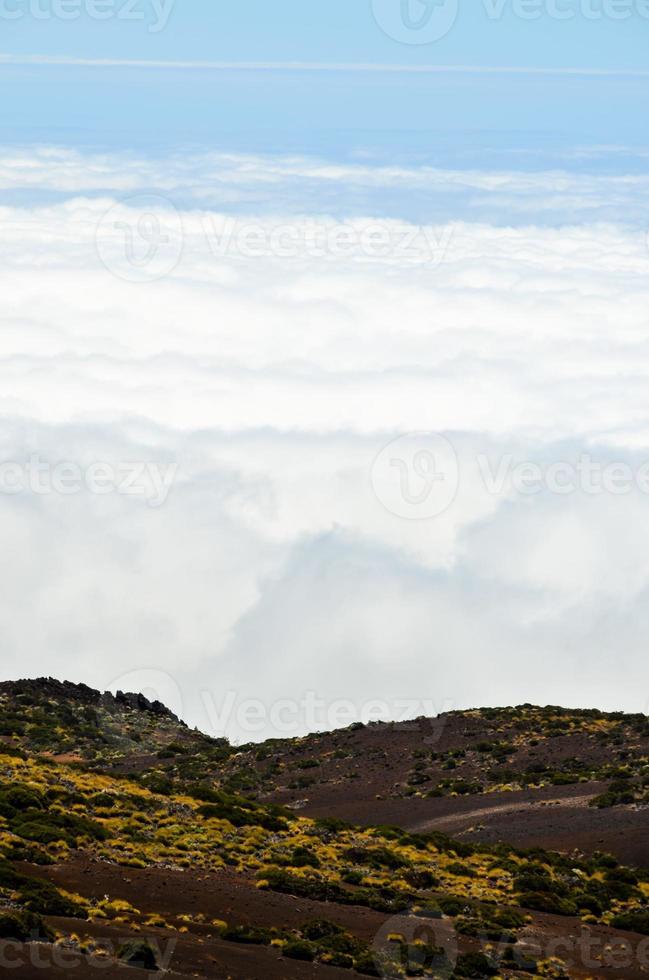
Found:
[0,679,649,865]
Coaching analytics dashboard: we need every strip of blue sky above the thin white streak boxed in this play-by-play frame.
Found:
[3,0,649,69]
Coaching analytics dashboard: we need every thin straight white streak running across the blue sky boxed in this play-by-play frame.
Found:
[0,53,649,78]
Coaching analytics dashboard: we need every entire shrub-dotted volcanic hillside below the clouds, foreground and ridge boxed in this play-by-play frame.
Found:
[0,680,649,980]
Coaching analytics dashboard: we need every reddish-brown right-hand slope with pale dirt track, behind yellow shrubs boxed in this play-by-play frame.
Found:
[220,706,649,864]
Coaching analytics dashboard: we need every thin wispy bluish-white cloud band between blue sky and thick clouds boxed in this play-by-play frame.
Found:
[0,146,649,224]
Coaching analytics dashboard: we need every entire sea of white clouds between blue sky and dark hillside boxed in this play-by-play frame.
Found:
[0,149,649,739]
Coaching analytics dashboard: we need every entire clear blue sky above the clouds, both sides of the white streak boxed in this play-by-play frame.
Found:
[0,0,649,157]
